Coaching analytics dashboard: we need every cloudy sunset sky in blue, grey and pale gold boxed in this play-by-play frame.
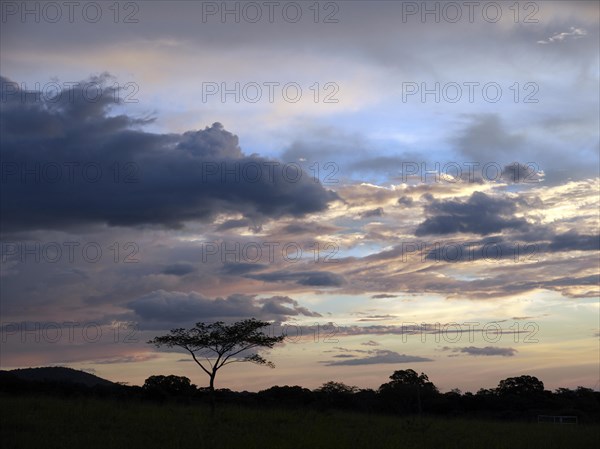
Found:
[0,1,600,392]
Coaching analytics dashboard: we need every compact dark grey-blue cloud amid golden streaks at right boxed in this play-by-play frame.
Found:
[415,192,529,236]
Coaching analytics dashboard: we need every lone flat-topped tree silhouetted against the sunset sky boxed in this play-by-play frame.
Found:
[148,318,285,410]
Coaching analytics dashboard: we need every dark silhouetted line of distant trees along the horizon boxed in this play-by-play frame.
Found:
[0,369,600,423]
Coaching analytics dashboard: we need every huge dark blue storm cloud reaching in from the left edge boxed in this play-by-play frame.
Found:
[0,75,337,232]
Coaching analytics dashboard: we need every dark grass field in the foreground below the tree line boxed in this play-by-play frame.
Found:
[0,396,600,449]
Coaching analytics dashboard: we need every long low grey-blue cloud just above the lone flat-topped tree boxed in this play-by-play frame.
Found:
[126,290,321,328]
